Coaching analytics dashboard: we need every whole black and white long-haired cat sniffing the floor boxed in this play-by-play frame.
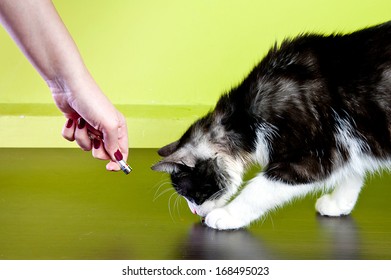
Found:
[152,21,391,230]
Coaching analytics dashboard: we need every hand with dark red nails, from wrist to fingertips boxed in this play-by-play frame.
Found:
[47,78,128,171]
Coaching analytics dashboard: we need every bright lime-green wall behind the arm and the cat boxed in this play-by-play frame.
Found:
[0,0,391,146]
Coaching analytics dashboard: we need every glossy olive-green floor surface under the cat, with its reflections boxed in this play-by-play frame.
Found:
[0,149,391,260]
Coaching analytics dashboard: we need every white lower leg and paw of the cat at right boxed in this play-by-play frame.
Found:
[315,175,364,217]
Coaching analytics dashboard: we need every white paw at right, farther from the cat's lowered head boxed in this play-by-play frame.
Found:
[315,194,354,217]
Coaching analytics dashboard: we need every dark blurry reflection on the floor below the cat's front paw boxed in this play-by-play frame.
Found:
[181,224,274,260]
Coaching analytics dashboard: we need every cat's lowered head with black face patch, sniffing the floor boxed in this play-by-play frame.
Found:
[152,114,244,217]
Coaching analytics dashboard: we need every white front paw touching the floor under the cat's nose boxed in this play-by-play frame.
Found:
[205,208,247,230]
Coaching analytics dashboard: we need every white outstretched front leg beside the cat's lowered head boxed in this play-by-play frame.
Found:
[205,173,314,230]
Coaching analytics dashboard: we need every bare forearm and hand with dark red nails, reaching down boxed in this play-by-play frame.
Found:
[0,0,128,170]
